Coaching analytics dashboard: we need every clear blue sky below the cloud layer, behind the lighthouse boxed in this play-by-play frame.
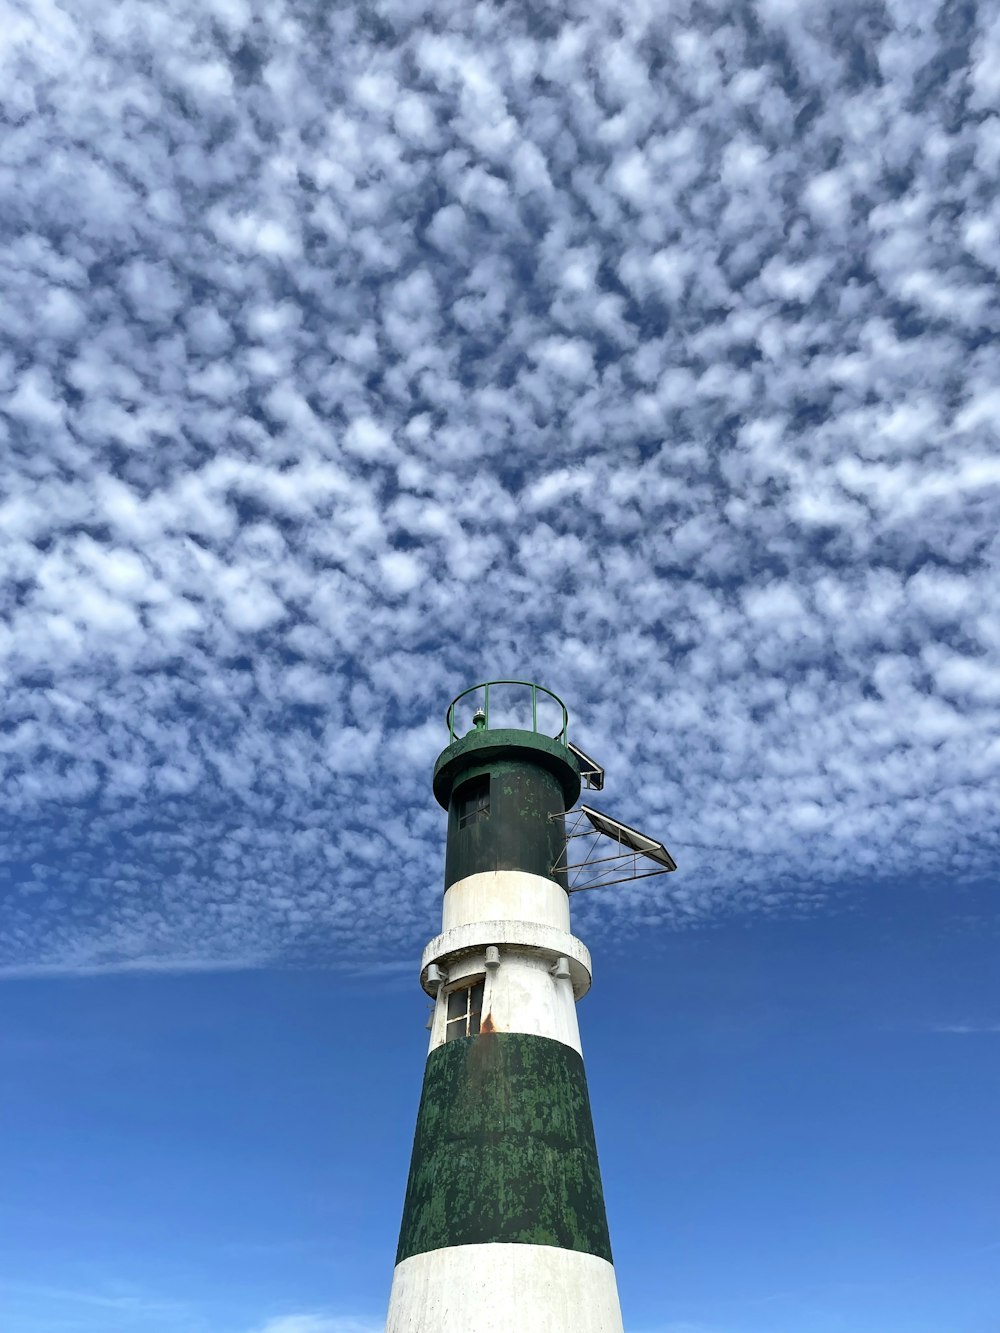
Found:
[0,885,1000,1333]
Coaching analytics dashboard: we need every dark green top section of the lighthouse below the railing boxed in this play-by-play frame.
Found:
[435,730,580,889]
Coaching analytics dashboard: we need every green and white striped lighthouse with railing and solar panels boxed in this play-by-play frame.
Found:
[387,681,675,1333]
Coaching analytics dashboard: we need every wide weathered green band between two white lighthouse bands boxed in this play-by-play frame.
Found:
[396,1018,611,1264]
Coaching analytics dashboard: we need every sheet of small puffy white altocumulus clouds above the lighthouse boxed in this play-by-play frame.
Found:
[0,0,1000,974]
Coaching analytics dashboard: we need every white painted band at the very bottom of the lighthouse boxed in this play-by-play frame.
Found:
[385,1244,623,1333]
